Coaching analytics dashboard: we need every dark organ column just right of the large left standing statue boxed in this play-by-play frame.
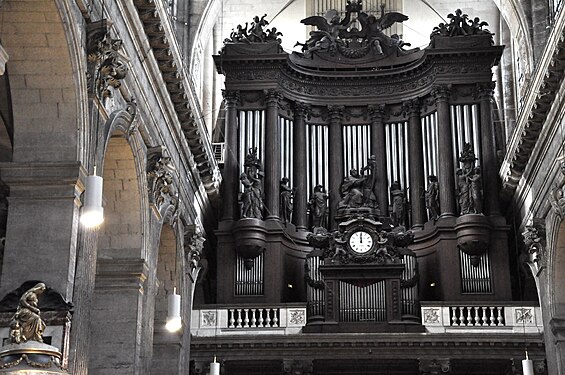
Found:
[265,89,281,220]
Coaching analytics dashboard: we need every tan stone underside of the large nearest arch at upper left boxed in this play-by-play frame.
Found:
[0,0,88,162]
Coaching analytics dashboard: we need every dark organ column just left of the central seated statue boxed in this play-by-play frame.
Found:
[328,106,344,229]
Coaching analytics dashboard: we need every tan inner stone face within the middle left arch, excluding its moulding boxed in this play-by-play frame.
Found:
[89,133,147,374]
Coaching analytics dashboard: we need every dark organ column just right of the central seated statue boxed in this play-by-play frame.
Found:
[368,105,388,216]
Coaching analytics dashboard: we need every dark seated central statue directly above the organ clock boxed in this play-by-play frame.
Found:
[338,155,379,209]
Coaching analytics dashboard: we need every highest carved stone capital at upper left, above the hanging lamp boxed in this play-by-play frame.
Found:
[86,19,128,99]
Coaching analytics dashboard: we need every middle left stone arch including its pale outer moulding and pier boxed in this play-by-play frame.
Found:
[88,111,152,374]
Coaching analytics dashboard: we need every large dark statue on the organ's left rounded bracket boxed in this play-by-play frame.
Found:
[239,147,263,219]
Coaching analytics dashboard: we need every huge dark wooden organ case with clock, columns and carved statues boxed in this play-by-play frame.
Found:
[214,1,511,332]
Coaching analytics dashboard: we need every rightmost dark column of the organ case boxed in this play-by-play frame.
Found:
[478,82,500,215]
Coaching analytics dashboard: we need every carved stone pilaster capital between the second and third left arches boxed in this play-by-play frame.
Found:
[147,146,179,219]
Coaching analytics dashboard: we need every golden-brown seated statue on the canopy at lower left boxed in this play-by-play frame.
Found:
[10,283,45,344]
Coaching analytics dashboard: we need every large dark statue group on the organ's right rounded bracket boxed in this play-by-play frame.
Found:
[457,143,483,215]
